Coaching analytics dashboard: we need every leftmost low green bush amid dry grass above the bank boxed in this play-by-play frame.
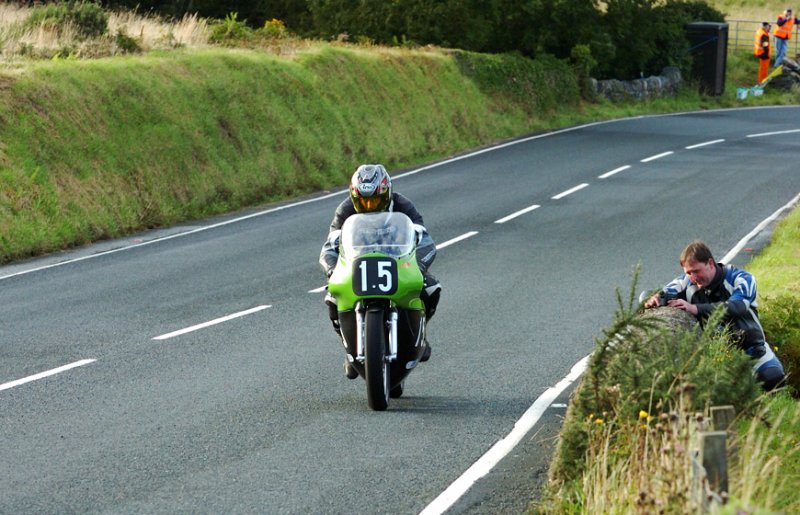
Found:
[23,0,108,39]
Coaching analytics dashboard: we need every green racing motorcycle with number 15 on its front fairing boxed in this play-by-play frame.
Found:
[328,212,426,411]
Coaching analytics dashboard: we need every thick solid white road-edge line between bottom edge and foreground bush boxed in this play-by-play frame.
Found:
[420,356,589,515]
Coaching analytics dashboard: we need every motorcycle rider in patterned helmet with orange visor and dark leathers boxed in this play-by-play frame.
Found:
[319,164,442,379]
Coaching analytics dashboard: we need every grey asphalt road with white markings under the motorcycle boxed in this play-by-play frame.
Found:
[0,107,800,513]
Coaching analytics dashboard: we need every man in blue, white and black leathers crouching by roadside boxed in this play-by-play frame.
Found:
[644,240,785,391]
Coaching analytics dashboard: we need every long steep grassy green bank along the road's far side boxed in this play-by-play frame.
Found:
[0,44,578,261]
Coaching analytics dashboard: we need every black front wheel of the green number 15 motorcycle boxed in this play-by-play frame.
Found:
[364,309,389,411]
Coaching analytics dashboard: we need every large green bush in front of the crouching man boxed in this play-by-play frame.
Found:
[550,281,762,495]
